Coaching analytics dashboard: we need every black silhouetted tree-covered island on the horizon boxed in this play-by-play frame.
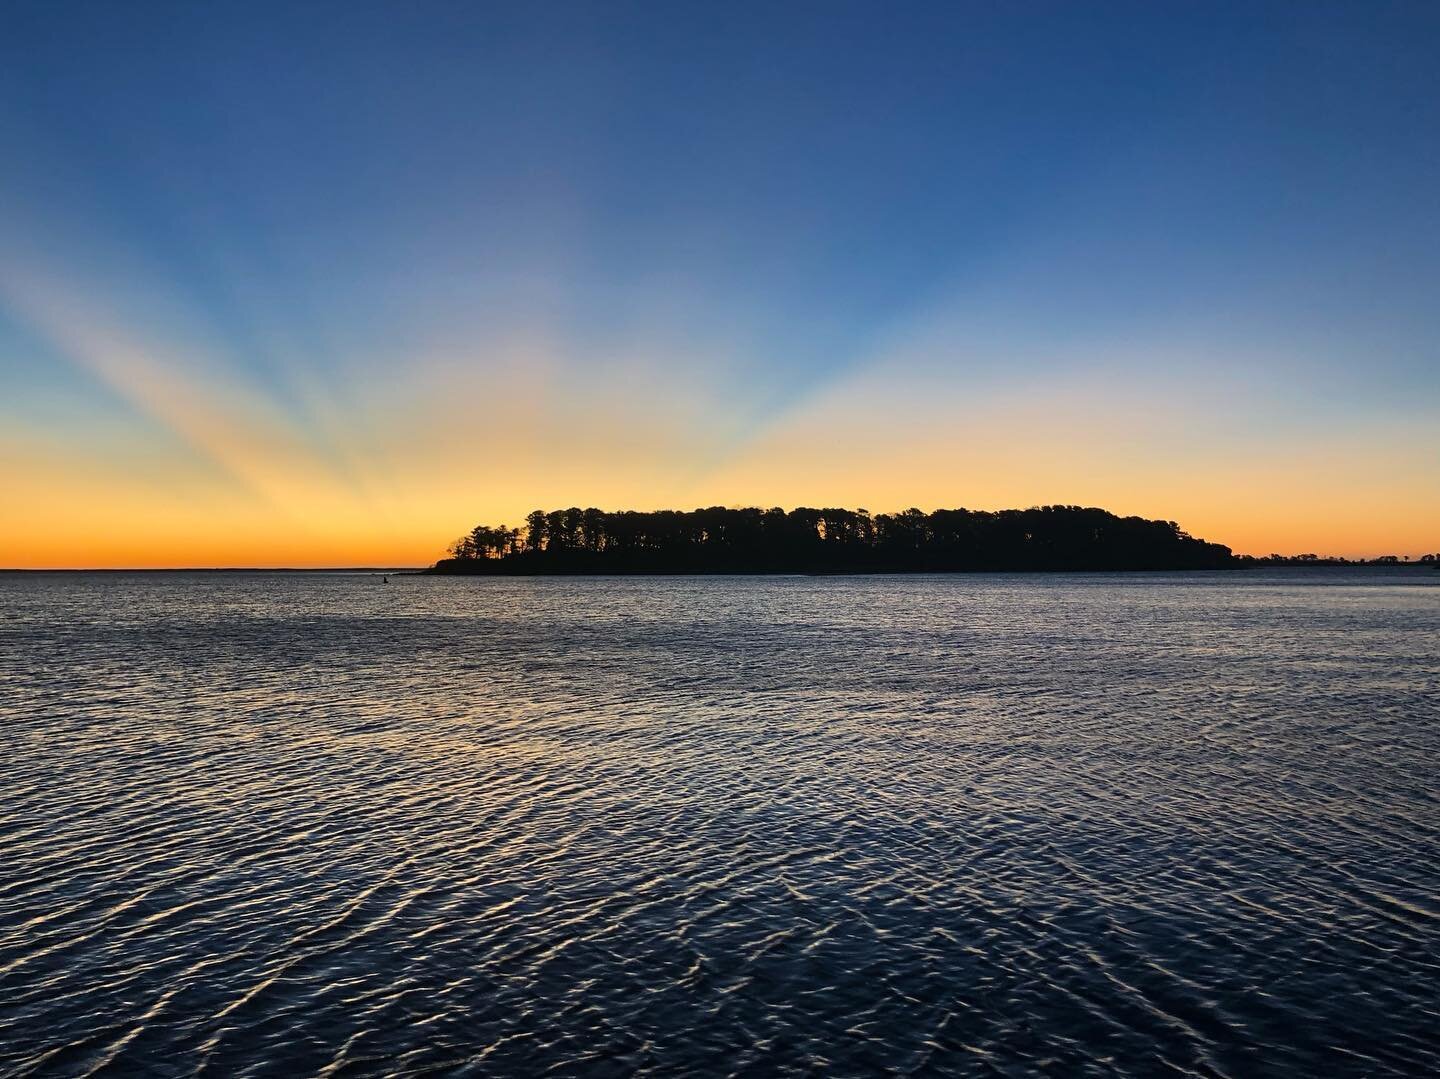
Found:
[431,506,1236,573]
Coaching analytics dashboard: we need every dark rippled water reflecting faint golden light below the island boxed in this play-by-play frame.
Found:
[0,570,1440,1076]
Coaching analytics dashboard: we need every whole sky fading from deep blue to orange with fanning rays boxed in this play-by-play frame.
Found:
[0,0,1440,568]
